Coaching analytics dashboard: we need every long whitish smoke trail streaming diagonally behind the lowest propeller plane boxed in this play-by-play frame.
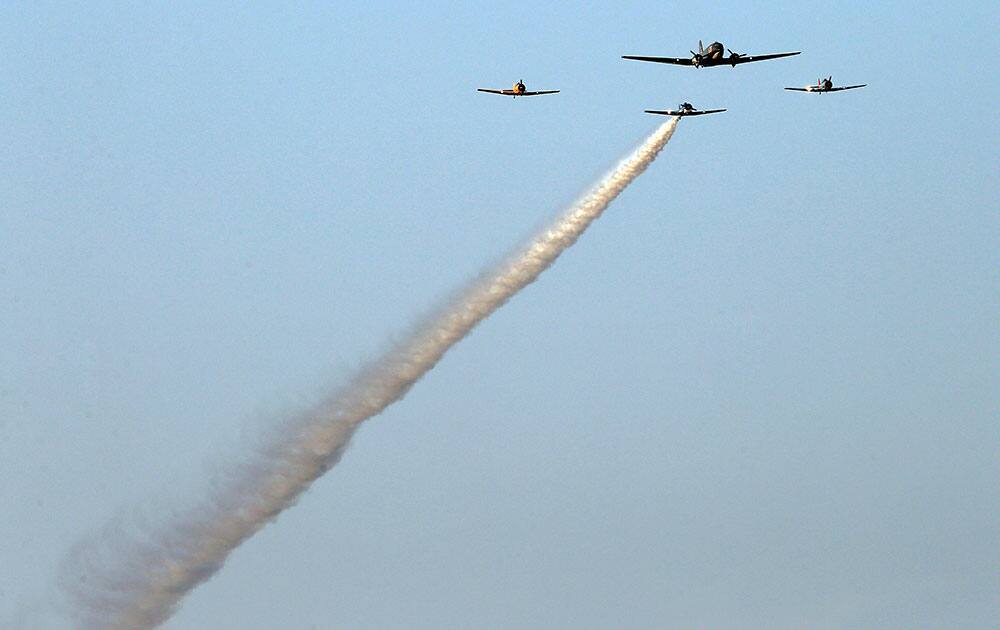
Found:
[62,118,678,630]
